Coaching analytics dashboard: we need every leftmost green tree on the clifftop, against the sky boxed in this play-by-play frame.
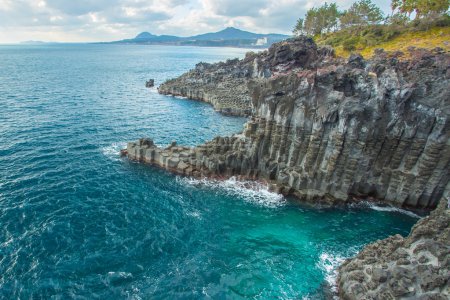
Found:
[293,2,340,35]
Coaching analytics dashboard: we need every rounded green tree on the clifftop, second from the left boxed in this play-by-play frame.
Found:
[340,0,384,28]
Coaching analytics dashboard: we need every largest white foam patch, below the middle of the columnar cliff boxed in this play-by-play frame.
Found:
[178,177,286,208]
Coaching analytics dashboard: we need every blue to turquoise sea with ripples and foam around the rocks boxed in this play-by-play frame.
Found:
[0,45,417,299]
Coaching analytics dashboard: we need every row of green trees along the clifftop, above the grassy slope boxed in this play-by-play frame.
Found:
[293,0,450,36]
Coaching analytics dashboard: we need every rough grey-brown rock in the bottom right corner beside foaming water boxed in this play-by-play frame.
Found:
[338,199,450,300]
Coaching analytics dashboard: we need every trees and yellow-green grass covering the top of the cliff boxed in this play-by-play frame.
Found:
[294,0,450,57]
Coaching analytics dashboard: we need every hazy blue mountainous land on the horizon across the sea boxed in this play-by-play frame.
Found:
[107,27,290,48]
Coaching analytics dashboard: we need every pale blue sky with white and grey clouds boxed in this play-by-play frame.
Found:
[0,0,390,43]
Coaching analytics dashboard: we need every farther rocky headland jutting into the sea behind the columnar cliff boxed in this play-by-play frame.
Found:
[158,38,326,116]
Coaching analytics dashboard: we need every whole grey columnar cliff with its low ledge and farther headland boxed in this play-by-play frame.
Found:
[132,38,450,208]
